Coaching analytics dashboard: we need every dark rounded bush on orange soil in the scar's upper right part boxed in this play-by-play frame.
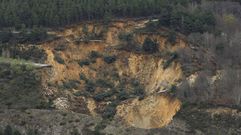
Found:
[142,38,159,53]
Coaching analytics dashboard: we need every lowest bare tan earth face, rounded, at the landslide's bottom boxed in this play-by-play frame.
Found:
[117,95,181,129]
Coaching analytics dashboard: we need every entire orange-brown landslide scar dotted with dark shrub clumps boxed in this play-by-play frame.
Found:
[0,20,187,129]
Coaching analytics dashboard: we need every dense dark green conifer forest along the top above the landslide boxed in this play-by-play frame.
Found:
[0,0,200,28]
